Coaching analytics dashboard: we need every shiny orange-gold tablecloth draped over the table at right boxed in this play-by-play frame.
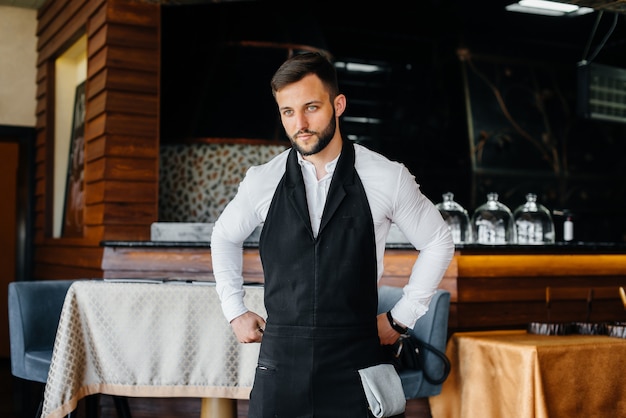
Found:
[430,331,626,418]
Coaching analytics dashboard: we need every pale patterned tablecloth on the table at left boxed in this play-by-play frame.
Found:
[42,280,266,418]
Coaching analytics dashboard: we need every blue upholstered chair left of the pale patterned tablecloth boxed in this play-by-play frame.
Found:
[8,280,130,418]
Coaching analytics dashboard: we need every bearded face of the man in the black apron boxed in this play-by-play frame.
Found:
[276,75,337,156]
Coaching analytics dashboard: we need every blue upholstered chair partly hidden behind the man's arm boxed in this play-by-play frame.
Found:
[378,286,450,399]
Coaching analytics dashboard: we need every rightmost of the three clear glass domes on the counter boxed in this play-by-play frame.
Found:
[513,193,554,244]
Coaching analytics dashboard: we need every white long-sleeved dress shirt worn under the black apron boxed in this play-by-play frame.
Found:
[211,144,454,328]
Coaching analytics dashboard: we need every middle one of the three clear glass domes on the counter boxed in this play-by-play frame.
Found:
[471,193,515,245]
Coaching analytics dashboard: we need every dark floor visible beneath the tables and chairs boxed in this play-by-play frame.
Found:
[0,358,432,418]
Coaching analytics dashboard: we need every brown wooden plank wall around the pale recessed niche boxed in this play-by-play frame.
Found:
[33,0,160,279]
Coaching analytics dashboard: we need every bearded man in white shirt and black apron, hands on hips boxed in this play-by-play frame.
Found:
[211,53,454,418]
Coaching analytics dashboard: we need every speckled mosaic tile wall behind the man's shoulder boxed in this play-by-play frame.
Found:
[159,144,287,222]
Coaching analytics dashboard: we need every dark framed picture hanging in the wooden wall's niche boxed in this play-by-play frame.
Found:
[61,82,85,237]
